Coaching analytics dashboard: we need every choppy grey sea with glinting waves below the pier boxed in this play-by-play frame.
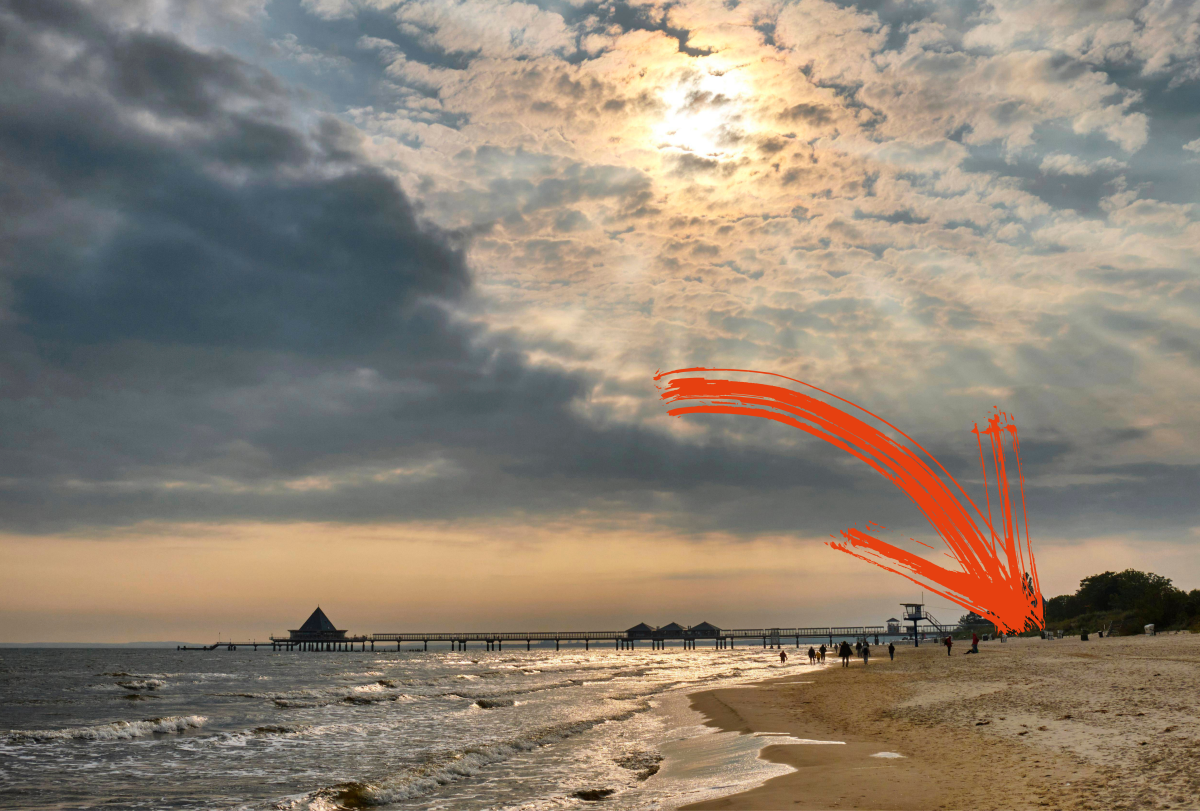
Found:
[0,643,821,811]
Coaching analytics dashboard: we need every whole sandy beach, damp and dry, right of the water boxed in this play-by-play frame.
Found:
[686,635,1200,810]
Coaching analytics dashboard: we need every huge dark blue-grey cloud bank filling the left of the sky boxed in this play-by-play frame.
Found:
[0,0,907,529]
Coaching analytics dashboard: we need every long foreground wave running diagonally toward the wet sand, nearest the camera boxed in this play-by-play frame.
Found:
[300,703,650,811]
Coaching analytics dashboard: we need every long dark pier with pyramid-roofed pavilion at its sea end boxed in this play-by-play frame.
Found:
[179,607,952,653]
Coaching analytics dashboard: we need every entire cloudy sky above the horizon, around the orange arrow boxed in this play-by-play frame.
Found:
[0,0,1200,642]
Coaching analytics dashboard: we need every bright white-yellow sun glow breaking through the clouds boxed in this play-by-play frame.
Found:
[653,67,751,160]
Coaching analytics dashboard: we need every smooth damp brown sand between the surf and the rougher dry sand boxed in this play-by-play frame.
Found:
[680,641,1093,811]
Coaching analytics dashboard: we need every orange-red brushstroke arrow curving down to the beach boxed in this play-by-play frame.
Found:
[654,367,1043,632]
